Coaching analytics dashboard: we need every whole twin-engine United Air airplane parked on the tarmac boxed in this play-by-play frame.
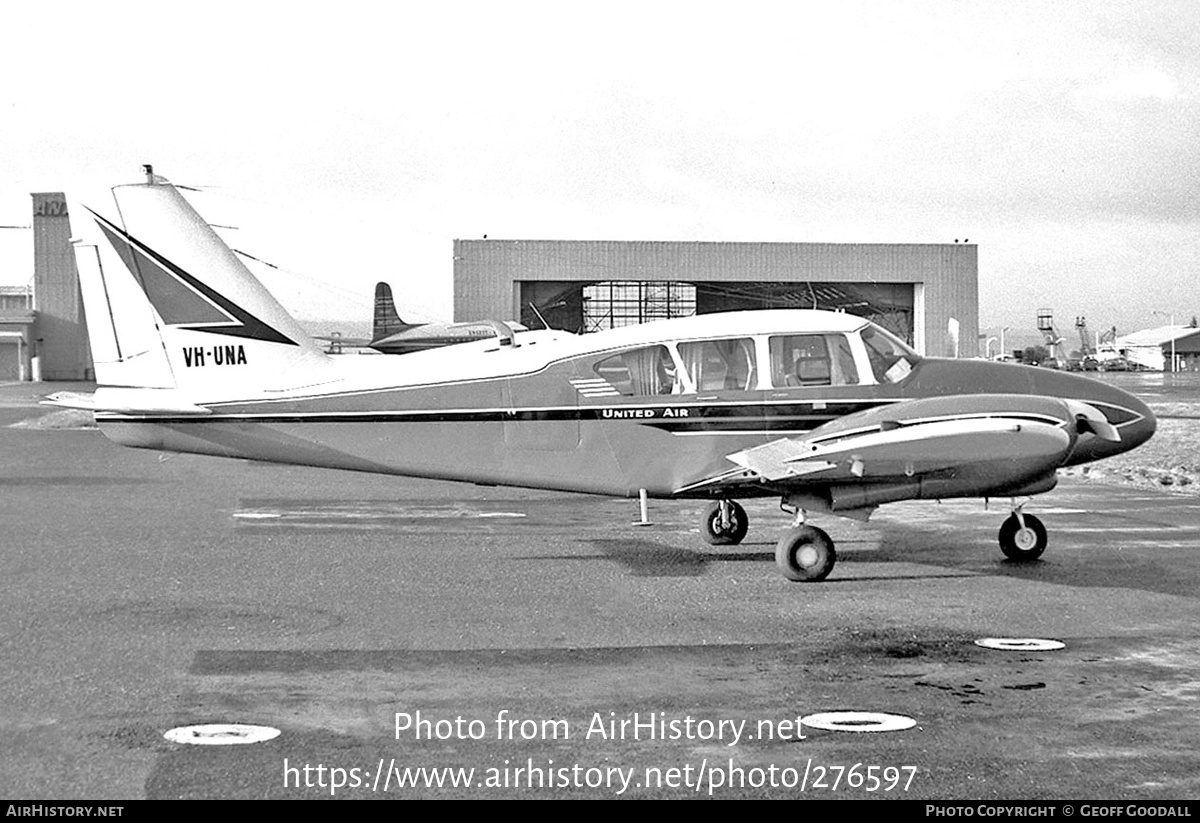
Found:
[60,176,1156,581]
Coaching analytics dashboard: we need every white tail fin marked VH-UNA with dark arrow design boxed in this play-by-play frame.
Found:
[76,176,326,402]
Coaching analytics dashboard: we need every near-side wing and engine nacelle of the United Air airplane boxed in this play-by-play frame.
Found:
[677,395,1104,510]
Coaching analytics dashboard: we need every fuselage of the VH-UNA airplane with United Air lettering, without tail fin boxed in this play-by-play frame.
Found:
[96,311,1154,498]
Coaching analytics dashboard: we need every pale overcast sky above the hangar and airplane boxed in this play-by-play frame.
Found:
[0,0,1200,334]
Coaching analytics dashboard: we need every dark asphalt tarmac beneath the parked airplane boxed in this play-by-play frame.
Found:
[0,392,1200,800]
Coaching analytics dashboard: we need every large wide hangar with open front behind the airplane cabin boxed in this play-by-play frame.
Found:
[454,240,979,358]
